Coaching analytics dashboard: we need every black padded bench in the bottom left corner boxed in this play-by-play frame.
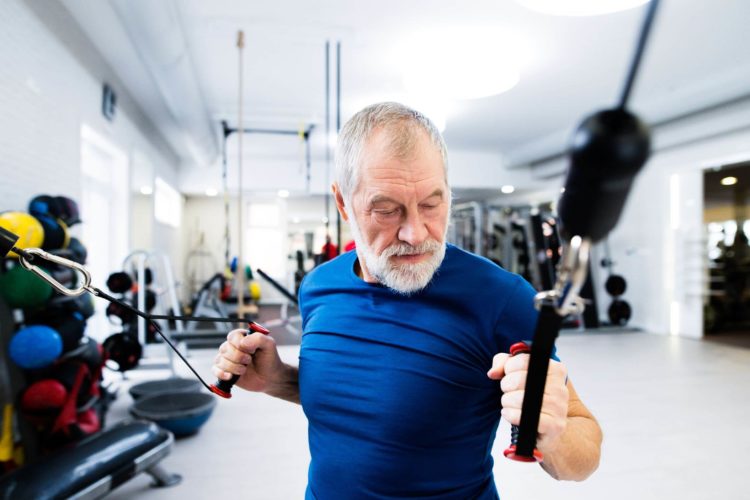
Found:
[0,420,182,500]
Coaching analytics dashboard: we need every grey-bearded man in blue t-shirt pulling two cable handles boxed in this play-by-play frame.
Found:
[214,103,602,500]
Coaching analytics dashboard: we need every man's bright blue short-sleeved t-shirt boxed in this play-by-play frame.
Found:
[299,245,537,500]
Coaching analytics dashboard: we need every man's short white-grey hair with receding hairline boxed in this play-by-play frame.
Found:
[336,102,448,203]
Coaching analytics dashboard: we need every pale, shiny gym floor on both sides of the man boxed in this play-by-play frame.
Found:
[101,330,750,500]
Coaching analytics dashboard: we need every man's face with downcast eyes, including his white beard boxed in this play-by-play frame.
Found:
[348,127,450,294]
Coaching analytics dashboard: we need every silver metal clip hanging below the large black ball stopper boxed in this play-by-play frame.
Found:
[534,236,591,316]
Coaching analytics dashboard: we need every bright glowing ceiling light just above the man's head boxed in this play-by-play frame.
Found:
[401,28,523,99]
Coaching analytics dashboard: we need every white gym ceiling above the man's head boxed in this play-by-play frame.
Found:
[63,0,750,169]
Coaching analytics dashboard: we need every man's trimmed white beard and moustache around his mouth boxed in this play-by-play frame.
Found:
[349,216,447,295]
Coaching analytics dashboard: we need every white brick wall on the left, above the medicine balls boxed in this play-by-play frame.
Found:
[0,0,184,334]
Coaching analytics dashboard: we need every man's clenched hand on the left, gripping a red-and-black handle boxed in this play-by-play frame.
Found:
[212,330,291,393]
